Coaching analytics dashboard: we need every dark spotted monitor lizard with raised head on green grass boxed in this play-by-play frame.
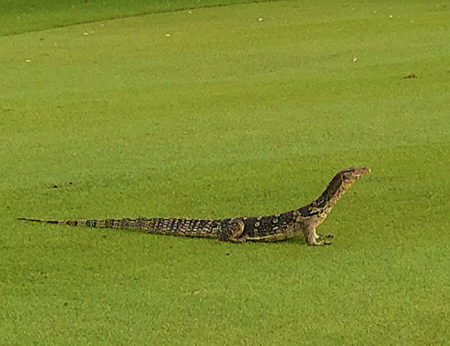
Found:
[18,167,370,246]
